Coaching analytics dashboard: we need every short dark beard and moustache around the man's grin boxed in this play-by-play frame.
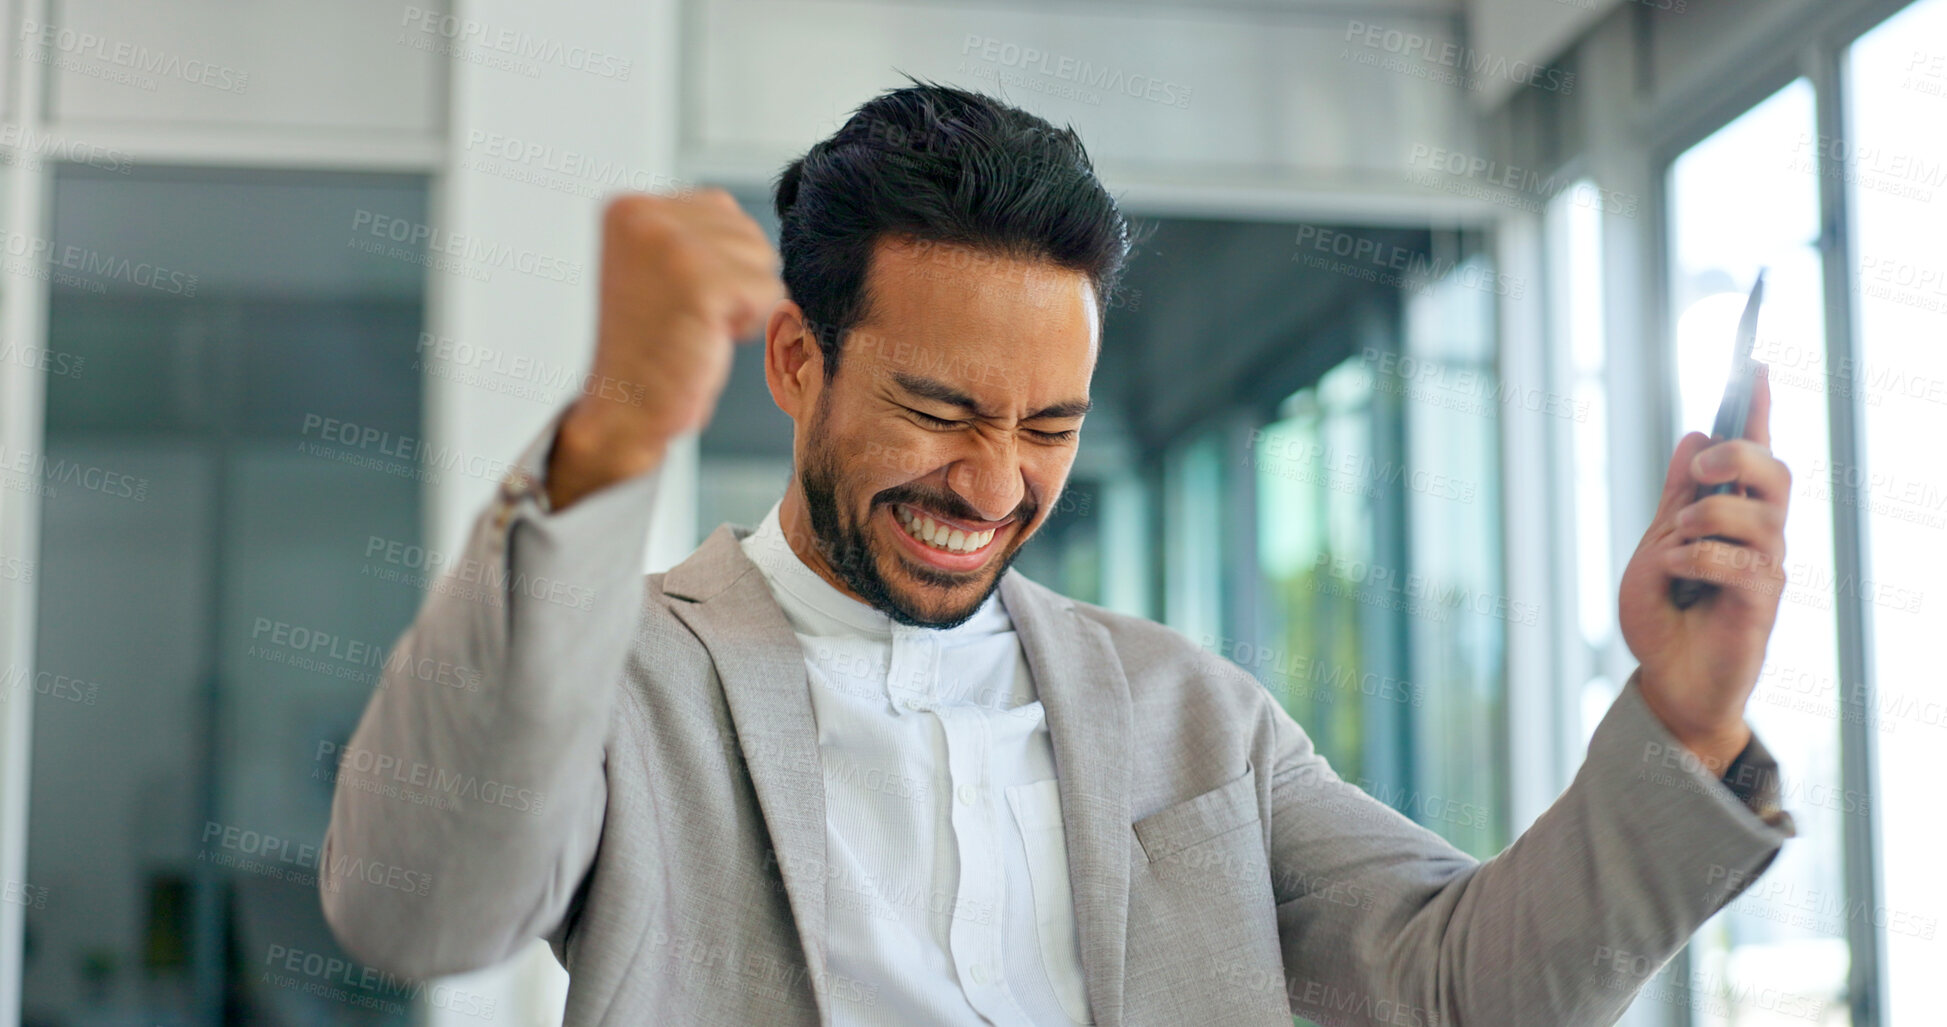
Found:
[798,398,1034,628]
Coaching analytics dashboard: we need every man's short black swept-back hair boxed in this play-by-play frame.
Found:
[777,76,1129,372]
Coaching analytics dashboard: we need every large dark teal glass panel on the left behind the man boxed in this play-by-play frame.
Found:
[23,168,426,1025]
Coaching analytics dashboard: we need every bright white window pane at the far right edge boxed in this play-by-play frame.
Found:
[1837,0,1947,1023]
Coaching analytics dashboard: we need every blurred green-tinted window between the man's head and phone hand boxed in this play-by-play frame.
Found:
[1225,257,1503,857]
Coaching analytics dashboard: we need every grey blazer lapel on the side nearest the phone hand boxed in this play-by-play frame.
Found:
[1001,571,1133,1025]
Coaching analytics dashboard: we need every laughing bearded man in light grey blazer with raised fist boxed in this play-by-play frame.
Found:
[323,84,1791,1025]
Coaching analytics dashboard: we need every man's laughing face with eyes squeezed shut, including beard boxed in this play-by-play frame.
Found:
[798,240,1098,628]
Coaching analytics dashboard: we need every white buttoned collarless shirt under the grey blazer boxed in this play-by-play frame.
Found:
[744,505,1092,1025]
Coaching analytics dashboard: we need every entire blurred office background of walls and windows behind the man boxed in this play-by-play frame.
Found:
[0,0,1947,1027]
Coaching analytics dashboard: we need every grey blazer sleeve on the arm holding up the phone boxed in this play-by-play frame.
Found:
[1269,676,1795,1027]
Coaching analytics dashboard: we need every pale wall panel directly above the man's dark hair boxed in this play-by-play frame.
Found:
[681,0,1474,221]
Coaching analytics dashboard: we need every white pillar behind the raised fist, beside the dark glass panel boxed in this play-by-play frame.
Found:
[426,0,695,1027]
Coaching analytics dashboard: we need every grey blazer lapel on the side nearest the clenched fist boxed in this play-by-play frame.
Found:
[664,524,831,1023]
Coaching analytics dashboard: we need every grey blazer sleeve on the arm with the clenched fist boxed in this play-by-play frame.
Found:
[317,413,658,976]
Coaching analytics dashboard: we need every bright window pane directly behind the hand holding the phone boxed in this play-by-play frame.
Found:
[1669,80,1850,1027]
